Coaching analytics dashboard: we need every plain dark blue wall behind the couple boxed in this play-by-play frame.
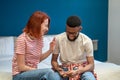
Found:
[0,0,108,61]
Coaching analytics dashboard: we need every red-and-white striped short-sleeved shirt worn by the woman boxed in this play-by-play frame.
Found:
[12,33,43,75]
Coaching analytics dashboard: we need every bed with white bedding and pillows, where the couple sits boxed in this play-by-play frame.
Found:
[0,35,120,80]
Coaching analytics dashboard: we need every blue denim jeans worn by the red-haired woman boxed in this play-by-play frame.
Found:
[13,68,60,80]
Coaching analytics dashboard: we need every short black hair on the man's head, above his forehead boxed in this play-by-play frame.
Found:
[66,16,81,27]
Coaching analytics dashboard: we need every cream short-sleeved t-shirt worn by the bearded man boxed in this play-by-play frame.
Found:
[53,32,93,64]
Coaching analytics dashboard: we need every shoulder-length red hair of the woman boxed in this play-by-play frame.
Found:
[23,11,50,38]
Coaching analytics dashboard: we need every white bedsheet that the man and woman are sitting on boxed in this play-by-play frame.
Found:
[0,56,120,80]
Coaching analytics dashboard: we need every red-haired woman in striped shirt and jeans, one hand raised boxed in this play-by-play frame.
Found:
[12,11,55,80]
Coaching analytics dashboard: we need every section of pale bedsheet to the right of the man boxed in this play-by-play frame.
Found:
[95,61,120,80]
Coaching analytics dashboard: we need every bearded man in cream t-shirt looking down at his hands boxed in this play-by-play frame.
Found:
[51,16,96,80]
